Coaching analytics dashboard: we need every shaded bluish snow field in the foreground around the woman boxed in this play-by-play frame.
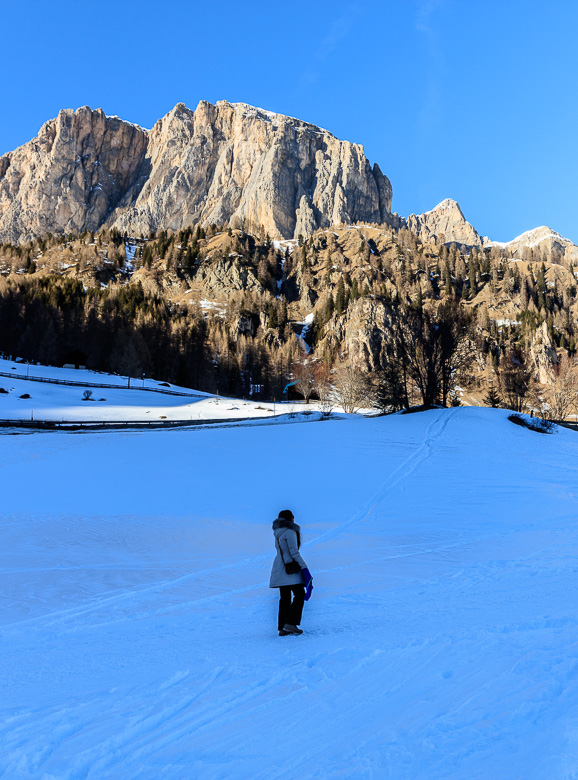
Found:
[0,406,578,780]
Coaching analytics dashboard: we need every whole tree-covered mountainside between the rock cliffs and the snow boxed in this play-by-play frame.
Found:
[0,219,577,409]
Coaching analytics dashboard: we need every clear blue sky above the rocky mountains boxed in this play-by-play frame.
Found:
[0,0,578,242]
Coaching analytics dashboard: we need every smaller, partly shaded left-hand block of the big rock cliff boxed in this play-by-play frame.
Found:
[0,106,147,243]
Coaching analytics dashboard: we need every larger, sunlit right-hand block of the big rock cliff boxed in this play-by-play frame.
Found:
[109,101,391,238]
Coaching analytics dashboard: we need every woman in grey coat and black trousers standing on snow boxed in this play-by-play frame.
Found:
[269,509,313,636]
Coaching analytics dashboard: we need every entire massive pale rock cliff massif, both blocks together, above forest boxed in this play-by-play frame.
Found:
[0,101,391,242]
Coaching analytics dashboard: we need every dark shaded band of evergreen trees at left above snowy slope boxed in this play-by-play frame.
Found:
[0,275,298,397]
